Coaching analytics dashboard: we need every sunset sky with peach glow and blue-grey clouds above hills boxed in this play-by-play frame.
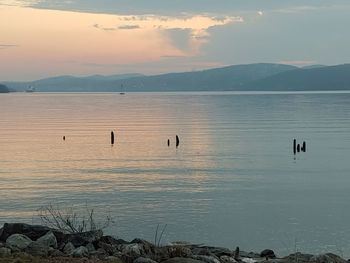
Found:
[0,0,350,81]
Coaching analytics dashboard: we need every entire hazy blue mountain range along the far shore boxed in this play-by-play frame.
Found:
[4,63,350,92]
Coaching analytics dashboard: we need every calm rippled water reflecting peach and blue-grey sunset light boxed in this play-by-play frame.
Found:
[0,93,350,256]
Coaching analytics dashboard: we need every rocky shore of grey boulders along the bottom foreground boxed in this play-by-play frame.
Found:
[0,223,348,263]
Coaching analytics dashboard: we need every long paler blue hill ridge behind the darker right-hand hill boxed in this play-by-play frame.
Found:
[7,63,297,92]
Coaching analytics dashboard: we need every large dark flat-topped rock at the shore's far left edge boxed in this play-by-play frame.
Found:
[0,223,51,241]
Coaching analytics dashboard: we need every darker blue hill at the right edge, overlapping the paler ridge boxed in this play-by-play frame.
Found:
[244,64,350,91]
